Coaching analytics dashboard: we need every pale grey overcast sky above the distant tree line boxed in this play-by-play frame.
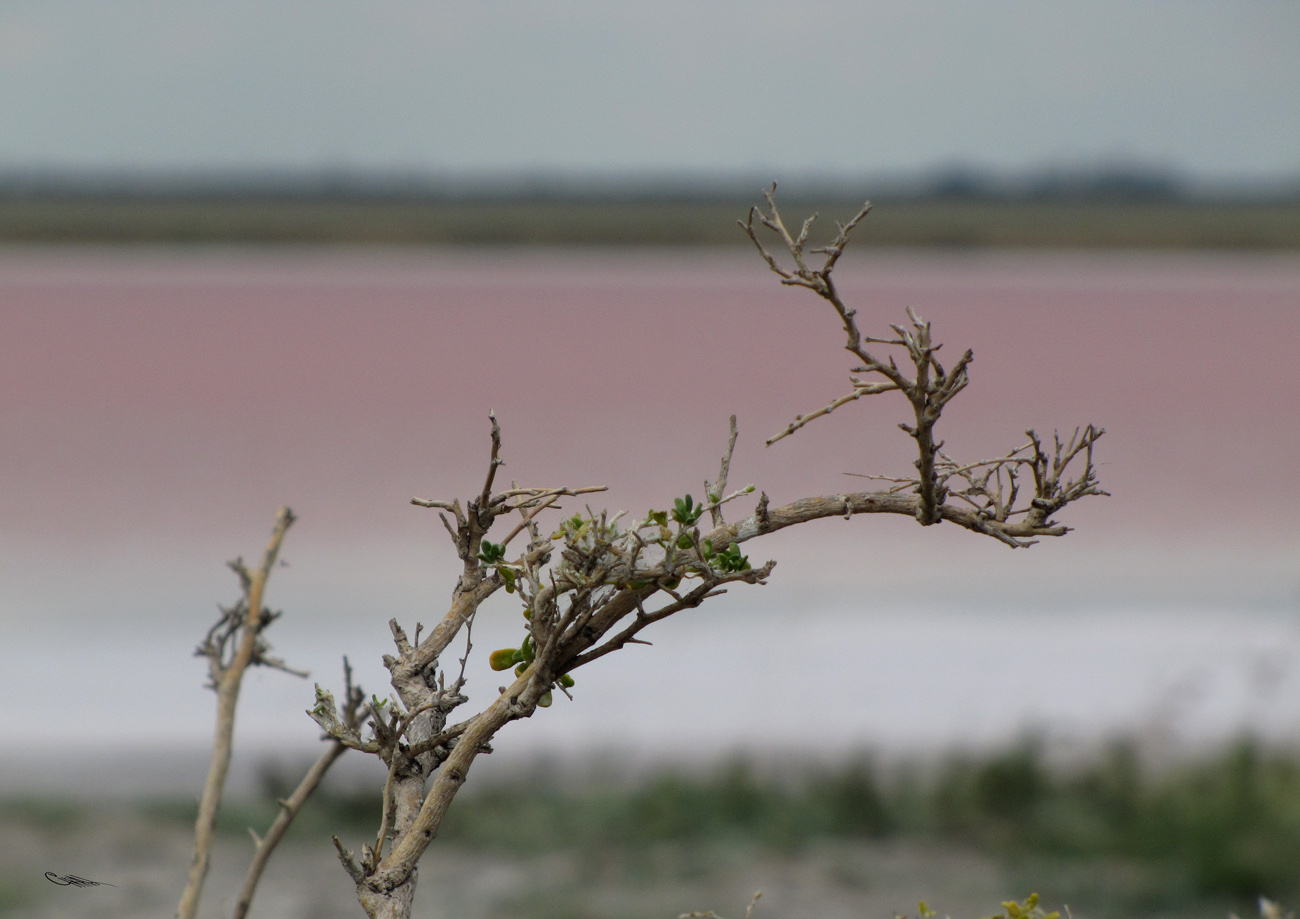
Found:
[0,0,1300,182]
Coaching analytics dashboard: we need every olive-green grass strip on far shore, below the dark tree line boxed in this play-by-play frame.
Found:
[0,196,1300,250]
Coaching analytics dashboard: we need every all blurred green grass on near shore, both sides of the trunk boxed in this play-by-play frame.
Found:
[10,740,1300,916]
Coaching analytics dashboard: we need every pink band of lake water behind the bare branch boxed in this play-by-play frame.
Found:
[0,245,1300,542]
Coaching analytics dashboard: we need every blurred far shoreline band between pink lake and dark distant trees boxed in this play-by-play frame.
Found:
[0,184,1300,251]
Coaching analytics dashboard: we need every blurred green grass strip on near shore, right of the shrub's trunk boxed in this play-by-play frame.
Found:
[403,741,1300,898]
